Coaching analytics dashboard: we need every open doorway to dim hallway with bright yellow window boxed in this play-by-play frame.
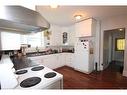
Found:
[103,28,125,73]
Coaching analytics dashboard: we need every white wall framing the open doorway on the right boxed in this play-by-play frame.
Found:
[100,15,127,76]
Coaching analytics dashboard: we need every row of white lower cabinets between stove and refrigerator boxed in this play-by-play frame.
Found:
[29,53,74,69]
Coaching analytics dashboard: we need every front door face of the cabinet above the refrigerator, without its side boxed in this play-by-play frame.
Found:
[75,19,92,37]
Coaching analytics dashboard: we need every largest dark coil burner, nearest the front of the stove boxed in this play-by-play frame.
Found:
[20,77,41,88]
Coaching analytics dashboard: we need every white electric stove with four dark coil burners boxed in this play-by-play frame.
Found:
[15,65,63,89]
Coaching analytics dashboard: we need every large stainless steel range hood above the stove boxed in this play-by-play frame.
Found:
[0,6,50,33]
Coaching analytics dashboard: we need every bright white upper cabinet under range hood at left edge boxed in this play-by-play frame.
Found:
[0,32,20,50]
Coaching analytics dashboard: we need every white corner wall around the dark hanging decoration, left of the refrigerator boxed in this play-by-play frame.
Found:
[49,25,75,46]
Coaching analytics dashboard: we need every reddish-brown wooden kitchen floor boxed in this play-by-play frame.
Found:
[55,63,127,89]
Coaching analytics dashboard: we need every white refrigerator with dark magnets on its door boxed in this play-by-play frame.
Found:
[74,38,94,74]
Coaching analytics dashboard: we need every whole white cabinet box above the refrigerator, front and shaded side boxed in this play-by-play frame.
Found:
[75,18,96,37]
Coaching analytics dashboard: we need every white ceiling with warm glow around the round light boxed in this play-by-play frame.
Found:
[36,6,127,26]
